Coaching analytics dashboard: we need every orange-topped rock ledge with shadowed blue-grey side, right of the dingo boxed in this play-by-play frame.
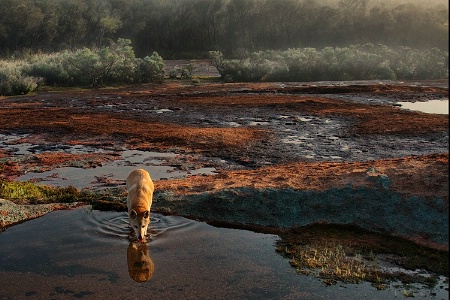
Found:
[153,154,449,251]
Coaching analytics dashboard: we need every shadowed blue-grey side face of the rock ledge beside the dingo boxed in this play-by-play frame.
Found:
[154,186,449,249]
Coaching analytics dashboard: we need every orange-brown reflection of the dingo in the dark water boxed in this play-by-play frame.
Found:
[127,242,155,282]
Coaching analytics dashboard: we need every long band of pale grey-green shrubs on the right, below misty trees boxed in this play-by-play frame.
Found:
[210,44,448,81]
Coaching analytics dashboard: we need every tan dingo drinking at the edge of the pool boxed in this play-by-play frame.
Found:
[127,169,154,242]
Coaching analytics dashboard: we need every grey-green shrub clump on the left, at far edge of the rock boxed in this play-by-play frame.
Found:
[0,39,164,95]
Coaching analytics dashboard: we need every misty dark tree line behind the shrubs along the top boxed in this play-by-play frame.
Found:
[0,0,449,59]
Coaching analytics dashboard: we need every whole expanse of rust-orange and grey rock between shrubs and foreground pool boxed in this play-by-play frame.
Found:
[0,81,449,251]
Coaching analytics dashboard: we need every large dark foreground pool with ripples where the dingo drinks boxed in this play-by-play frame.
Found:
[0,207,448,299]
